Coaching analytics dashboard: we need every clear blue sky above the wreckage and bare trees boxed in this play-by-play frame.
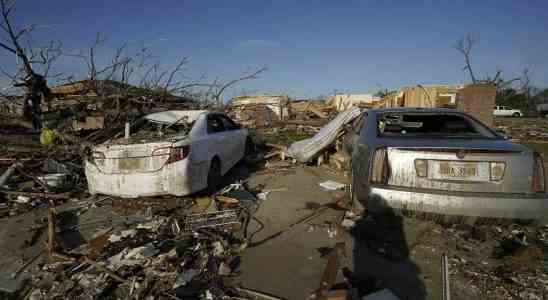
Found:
[0,0,548,97]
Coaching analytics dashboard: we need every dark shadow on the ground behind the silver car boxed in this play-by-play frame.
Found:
[343,212,427,300]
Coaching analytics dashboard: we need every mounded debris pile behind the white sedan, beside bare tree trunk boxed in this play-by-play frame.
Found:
[0,80,198,135]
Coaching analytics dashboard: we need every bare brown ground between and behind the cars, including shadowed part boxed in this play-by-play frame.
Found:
[233,167,548,300]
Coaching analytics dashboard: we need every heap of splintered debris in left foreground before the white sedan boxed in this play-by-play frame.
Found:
[7,185,264,299]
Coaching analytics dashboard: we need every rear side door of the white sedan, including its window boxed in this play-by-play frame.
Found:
[207,114,231,174]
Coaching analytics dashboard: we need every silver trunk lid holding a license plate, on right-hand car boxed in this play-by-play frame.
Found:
[385,141,533,193]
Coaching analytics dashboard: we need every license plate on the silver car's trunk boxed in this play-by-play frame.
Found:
[428,161,489,181]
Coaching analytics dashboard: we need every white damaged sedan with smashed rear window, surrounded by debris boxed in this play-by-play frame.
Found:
[85,110,251,198]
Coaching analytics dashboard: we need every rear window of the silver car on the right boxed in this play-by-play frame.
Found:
[377,113,498,139]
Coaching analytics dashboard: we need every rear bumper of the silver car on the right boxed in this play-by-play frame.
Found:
[367,187,548,219]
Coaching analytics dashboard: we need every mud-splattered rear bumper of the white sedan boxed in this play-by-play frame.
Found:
[85,159,196,198]
